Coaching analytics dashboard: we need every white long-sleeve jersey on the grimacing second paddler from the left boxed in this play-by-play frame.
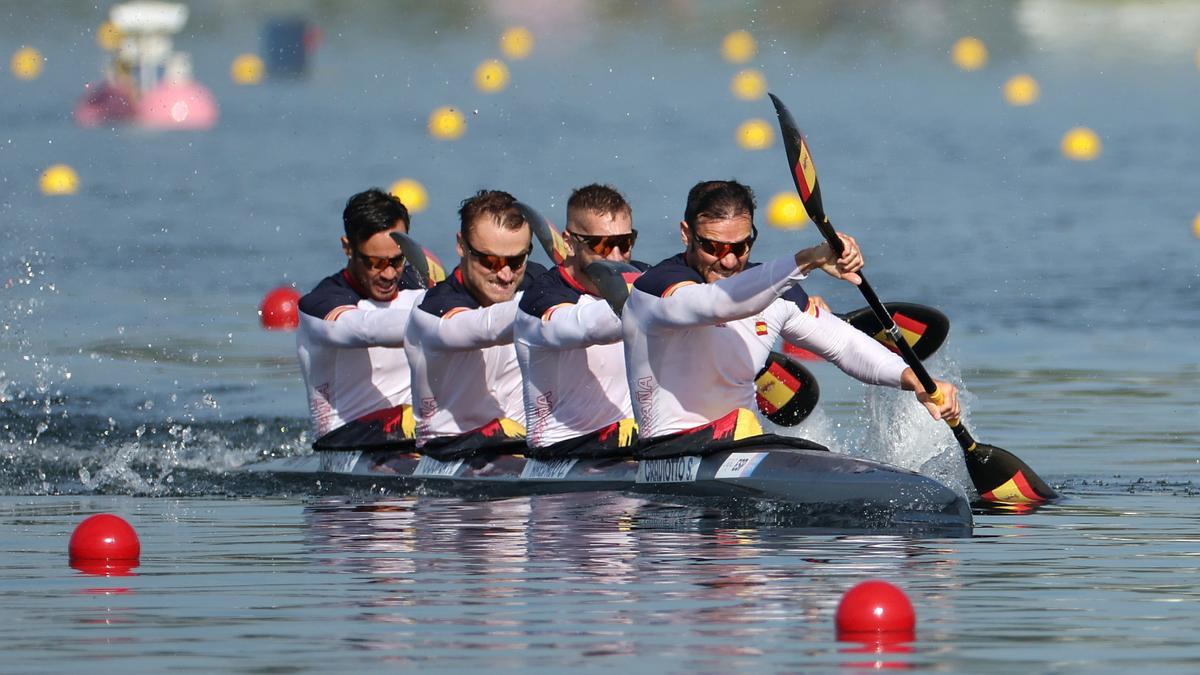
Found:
[404,263,545,447]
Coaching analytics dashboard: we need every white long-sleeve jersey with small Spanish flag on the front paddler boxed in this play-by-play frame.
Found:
[622,253,905,440]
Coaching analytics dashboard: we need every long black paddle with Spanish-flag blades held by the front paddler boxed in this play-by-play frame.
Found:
[770,94,1058,503]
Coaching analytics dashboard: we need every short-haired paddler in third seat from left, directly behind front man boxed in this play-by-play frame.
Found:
[515,184,646,459]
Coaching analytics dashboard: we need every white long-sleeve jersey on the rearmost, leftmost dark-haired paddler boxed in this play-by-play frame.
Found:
[296,270,425,438]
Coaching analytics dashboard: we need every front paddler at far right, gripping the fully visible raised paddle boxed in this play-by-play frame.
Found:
[622,180,959,458]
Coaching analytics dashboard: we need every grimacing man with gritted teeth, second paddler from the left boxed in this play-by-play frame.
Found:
[404,190,545,461]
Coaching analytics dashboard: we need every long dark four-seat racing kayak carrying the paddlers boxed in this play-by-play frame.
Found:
[246,442,972,536]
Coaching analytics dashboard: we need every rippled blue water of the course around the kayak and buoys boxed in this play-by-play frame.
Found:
[0,0,1200,671]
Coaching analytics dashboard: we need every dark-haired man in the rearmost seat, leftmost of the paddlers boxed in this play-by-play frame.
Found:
[296,189,424,441]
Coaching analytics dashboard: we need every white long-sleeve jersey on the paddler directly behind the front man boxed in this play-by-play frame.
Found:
[514,267,648,448]
